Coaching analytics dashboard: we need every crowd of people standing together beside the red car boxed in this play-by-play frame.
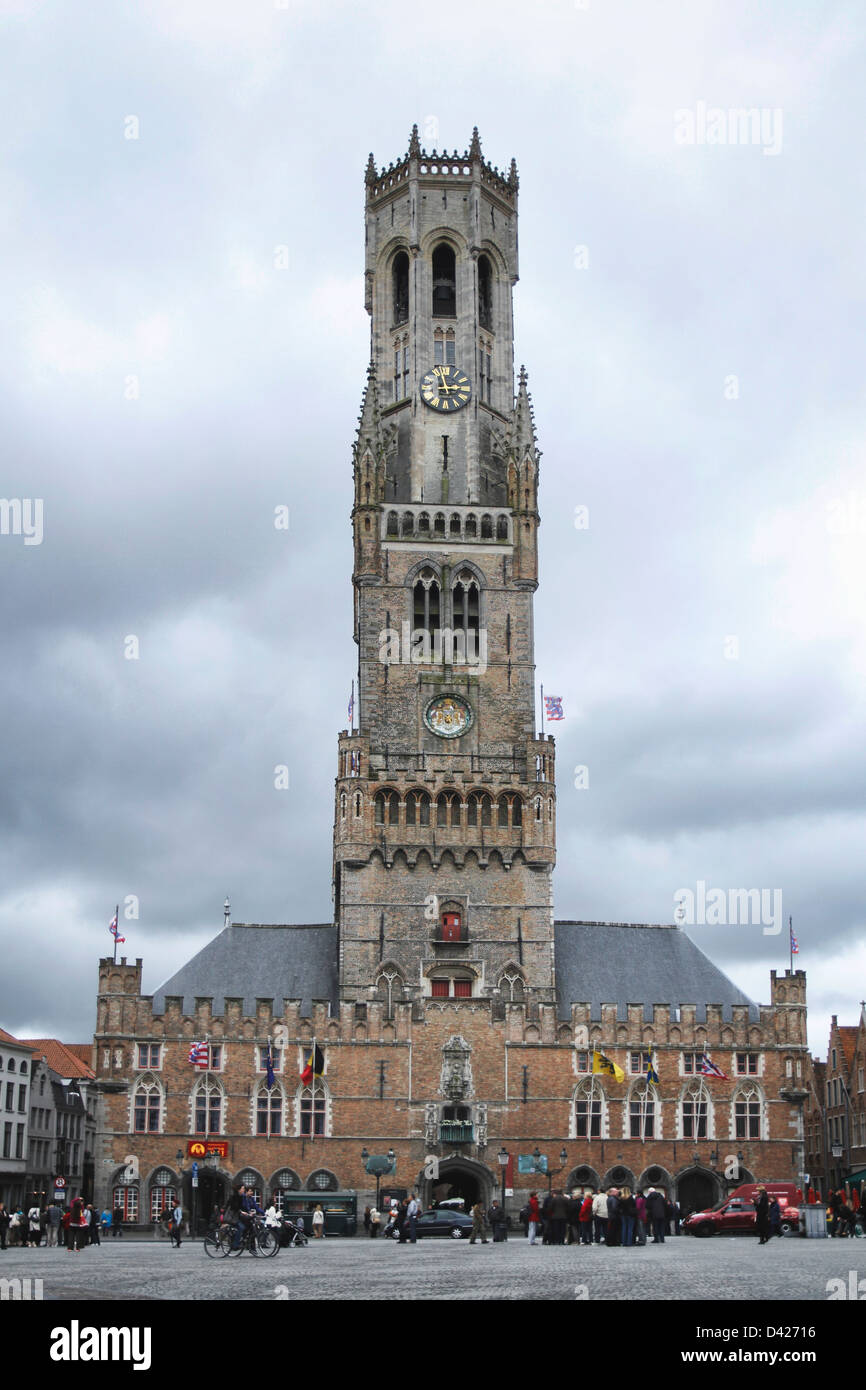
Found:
[520,1187,680,1247]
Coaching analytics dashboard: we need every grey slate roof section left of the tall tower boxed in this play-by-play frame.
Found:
[153,922,338,1016]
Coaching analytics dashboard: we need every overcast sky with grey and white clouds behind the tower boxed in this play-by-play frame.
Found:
[0,0,866,1055]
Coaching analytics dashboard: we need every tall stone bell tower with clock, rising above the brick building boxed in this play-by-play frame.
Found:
[334,126,556,1012]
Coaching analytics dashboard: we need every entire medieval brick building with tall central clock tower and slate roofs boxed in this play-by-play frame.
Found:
[93,131,808,1220]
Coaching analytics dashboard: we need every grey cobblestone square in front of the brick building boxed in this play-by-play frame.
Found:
[0,1236,866,1301]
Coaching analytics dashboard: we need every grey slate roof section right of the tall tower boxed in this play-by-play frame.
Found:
[553,922,759,1023]
